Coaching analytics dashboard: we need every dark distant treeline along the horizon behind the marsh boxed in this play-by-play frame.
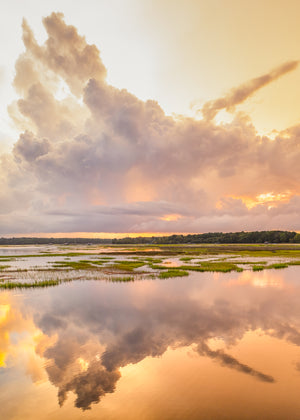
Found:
[0,230,300,245]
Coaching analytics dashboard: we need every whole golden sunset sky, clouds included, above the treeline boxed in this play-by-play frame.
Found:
[0,0,300,236]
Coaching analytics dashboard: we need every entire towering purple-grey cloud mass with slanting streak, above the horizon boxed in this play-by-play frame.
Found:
[0,13,300,234]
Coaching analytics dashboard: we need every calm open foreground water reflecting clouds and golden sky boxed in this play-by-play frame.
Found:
[0,266,300,420]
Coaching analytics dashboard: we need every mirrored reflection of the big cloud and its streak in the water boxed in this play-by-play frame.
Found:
[1,270,300,410]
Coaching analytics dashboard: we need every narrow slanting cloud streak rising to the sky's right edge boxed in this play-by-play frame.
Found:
[202,60,299,120]
